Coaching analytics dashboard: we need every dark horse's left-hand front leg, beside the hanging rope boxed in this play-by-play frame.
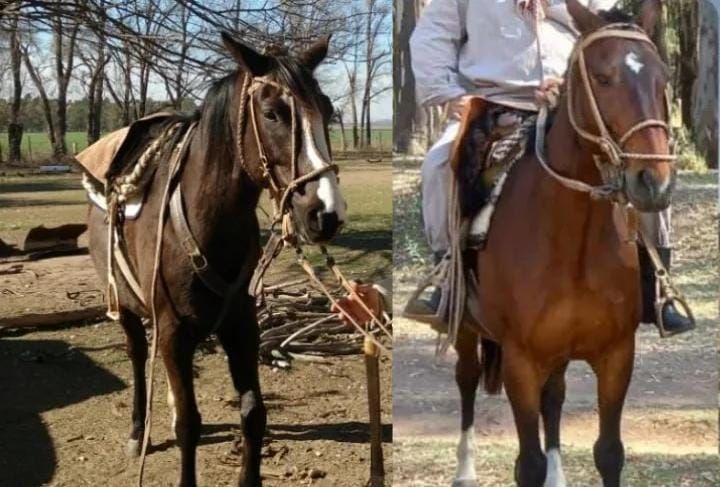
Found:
[159,322,201,487]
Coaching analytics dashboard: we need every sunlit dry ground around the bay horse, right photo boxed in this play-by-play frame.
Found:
[393,166,720,487]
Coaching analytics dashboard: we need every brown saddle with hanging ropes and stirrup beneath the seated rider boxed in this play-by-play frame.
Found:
[403,98,536,336]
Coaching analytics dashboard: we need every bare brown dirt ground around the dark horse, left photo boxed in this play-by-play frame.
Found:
[0,162,392,487]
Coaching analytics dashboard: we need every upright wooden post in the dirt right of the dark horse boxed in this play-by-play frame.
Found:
[363,337,385,487]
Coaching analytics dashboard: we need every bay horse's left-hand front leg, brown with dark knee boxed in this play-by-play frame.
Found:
[502,344,548,487]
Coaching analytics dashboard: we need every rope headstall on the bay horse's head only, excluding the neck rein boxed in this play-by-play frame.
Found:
[567,23,678,197]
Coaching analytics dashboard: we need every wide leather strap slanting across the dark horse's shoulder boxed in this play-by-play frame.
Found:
[170,182,229,297]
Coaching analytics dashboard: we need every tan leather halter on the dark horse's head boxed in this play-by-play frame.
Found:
[235,75,338,241]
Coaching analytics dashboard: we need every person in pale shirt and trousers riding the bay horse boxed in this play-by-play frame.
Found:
[410,0,694,336]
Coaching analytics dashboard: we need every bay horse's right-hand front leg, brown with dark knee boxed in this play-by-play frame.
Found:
[590,334,635,487]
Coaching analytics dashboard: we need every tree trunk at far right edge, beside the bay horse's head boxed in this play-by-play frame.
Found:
[687,0,720,168]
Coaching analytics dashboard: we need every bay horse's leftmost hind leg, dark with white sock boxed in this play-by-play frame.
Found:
[453,326,480,487]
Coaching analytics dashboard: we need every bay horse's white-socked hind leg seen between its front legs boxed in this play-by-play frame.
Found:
[540,362,568,487]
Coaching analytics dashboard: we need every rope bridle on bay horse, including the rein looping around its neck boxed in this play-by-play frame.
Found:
[536,23,678,203]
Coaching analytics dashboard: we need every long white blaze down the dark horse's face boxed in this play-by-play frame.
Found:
[300,109,345,222]
